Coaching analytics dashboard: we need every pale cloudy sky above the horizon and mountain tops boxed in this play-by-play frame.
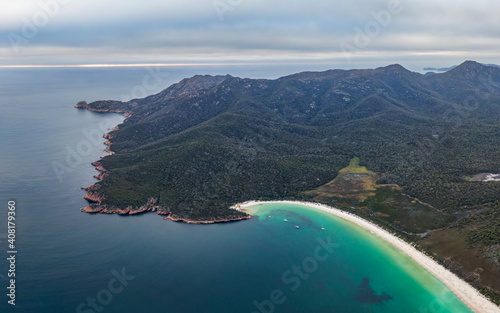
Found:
[0,0,500,68]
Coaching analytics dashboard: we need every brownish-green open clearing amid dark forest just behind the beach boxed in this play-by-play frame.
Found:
[305,157,457,234]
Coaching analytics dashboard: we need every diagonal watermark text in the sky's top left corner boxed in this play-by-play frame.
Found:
[7,0,71,53]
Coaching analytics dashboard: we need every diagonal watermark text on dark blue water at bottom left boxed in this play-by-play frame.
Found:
[76,268,135,313]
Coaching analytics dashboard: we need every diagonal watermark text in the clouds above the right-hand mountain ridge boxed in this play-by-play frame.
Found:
[340,0,411,62]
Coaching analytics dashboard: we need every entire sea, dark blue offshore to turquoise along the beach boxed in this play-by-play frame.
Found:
[0,65,470,313]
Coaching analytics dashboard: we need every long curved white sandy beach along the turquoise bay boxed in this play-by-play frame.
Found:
[235,201,500,313]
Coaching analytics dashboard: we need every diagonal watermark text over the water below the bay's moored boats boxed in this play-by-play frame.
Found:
[252,237,340,313]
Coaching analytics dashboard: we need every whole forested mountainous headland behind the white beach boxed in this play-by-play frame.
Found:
[78,62,500,300]
